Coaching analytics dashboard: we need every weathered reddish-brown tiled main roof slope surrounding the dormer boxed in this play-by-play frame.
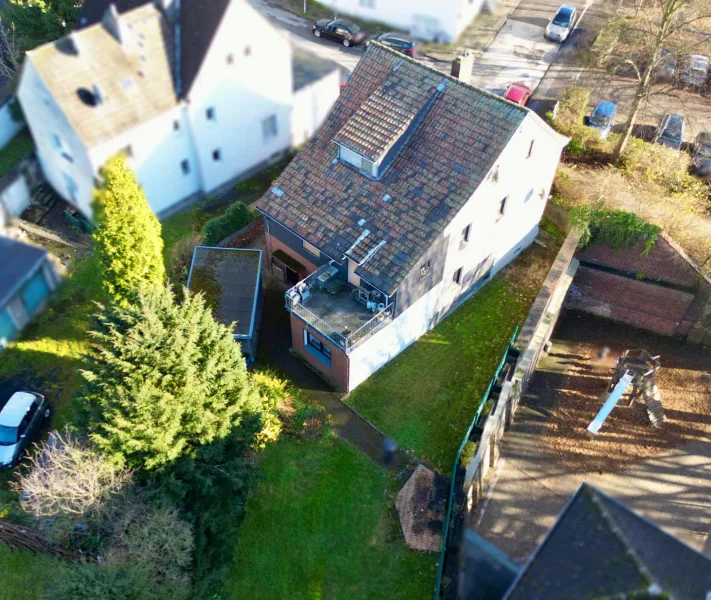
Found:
[258,43,528,294]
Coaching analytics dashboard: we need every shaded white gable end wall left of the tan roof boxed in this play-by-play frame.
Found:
[17,56,94,215]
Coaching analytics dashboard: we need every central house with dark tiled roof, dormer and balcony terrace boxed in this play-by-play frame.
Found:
[257,43,567,391]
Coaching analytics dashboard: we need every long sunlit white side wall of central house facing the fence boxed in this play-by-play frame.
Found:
[348,116,564,392]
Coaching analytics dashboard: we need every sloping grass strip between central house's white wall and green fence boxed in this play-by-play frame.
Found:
[347,278,535,473]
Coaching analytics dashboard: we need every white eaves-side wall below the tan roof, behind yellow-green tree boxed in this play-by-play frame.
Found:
[90,105,202,214]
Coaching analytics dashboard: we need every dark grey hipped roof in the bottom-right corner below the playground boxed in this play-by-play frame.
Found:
[505,483,711,600]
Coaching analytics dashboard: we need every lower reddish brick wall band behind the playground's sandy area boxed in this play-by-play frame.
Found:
[568,265,695,335]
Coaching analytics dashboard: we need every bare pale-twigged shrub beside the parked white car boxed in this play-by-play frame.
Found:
[12,431,131,517]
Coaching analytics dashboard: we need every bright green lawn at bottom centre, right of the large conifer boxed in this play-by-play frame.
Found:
[225,434,437,600]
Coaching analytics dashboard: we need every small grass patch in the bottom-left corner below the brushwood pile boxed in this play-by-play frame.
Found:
[0,545,60,600]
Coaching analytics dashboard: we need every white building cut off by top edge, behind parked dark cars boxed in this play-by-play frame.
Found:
[321,0,498,42]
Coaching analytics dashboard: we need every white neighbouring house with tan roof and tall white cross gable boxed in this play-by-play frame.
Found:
[17,0,340,217]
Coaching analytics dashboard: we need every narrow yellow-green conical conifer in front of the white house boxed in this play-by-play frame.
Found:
[93,154,165,306]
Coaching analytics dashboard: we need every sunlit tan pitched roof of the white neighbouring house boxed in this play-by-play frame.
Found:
[27,4,177,147]
